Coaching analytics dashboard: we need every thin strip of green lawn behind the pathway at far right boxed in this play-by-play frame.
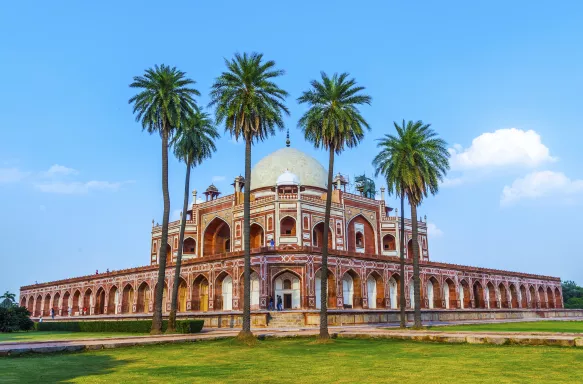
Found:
[427,321,583,333]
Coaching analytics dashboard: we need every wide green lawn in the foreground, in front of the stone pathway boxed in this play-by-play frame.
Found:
[0,338,583,384]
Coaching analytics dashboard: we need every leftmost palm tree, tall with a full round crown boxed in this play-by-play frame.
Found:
[129,64,200,334]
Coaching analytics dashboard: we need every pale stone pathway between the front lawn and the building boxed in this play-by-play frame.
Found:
[0,324,583,356]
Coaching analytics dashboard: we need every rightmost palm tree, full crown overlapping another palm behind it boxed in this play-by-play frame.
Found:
[384,120,449,328]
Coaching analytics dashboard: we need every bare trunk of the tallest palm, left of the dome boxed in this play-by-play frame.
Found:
[239,139,253,339]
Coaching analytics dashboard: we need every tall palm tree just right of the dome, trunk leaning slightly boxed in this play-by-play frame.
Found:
[298,72,371,339]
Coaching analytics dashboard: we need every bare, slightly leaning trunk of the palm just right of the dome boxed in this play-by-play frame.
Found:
[319,148,334,340]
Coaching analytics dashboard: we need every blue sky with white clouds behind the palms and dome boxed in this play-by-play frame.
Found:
[0,1,583,292]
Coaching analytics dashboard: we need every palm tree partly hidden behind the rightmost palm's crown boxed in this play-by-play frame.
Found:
[373,122,408,328]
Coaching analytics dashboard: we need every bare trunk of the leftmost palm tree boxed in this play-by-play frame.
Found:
[150,127,170,335]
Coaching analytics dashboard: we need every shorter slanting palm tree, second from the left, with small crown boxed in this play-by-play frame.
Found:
[166,107,219,333]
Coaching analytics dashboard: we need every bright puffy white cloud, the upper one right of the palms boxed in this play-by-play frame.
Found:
[449,128,557,170]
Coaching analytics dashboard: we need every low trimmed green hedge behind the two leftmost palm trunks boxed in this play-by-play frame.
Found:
[35,320,204,333]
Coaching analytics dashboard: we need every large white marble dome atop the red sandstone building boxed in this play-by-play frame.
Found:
[250,147,328,190]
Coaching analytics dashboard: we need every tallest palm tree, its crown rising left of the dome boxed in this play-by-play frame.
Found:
[210,53,289,340]
